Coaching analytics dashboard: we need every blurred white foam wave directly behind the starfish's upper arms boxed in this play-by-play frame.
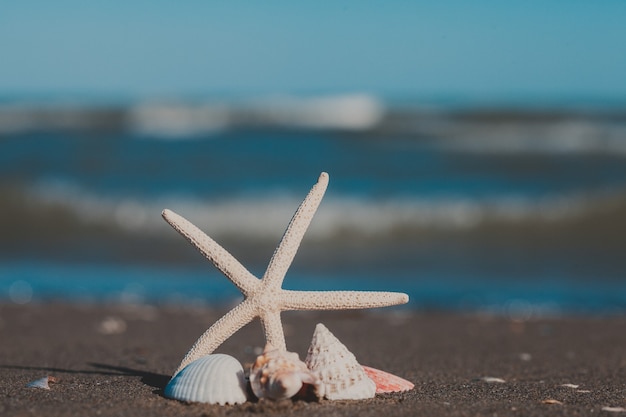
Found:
[25,180,623,240]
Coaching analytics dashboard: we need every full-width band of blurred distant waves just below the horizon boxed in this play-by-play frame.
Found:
[0,93,626,156]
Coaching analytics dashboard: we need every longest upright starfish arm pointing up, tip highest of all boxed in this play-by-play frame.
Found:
[263,172,328,288]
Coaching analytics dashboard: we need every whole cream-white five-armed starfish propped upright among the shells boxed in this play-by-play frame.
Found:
[162,172,409,375]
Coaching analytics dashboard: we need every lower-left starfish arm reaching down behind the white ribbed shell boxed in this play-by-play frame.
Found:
[172,301,258,377]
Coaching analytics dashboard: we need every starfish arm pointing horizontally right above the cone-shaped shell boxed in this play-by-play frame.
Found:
[281,290,409,310]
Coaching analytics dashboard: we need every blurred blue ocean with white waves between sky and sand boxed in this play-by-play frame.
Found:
[0,96,626,317]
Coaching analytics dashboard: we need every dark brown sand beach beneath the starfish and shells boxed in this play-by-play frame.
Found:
[0,305,626,417]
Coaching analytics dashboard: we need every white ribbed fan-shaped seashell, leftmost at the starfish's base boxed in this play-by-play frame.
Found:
[164,353,248,405]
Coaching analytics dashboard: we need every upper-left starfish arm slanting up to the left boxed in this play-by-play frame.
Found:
[162,209,259,296]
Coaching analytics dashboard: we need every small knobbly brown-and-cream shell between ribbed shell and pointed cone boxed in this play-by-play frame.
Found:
[250,344,320,400]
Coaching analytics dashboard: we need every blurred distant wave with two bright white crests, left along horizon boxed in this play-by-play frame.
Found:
[0,93,385,135]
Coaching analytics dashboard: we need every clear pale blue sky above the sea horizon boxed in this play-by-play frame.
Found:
[0,0,626,100]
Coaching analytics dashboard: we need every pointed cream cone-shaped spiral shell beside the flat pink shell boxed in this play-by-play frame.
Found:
[305,323,376,400]
